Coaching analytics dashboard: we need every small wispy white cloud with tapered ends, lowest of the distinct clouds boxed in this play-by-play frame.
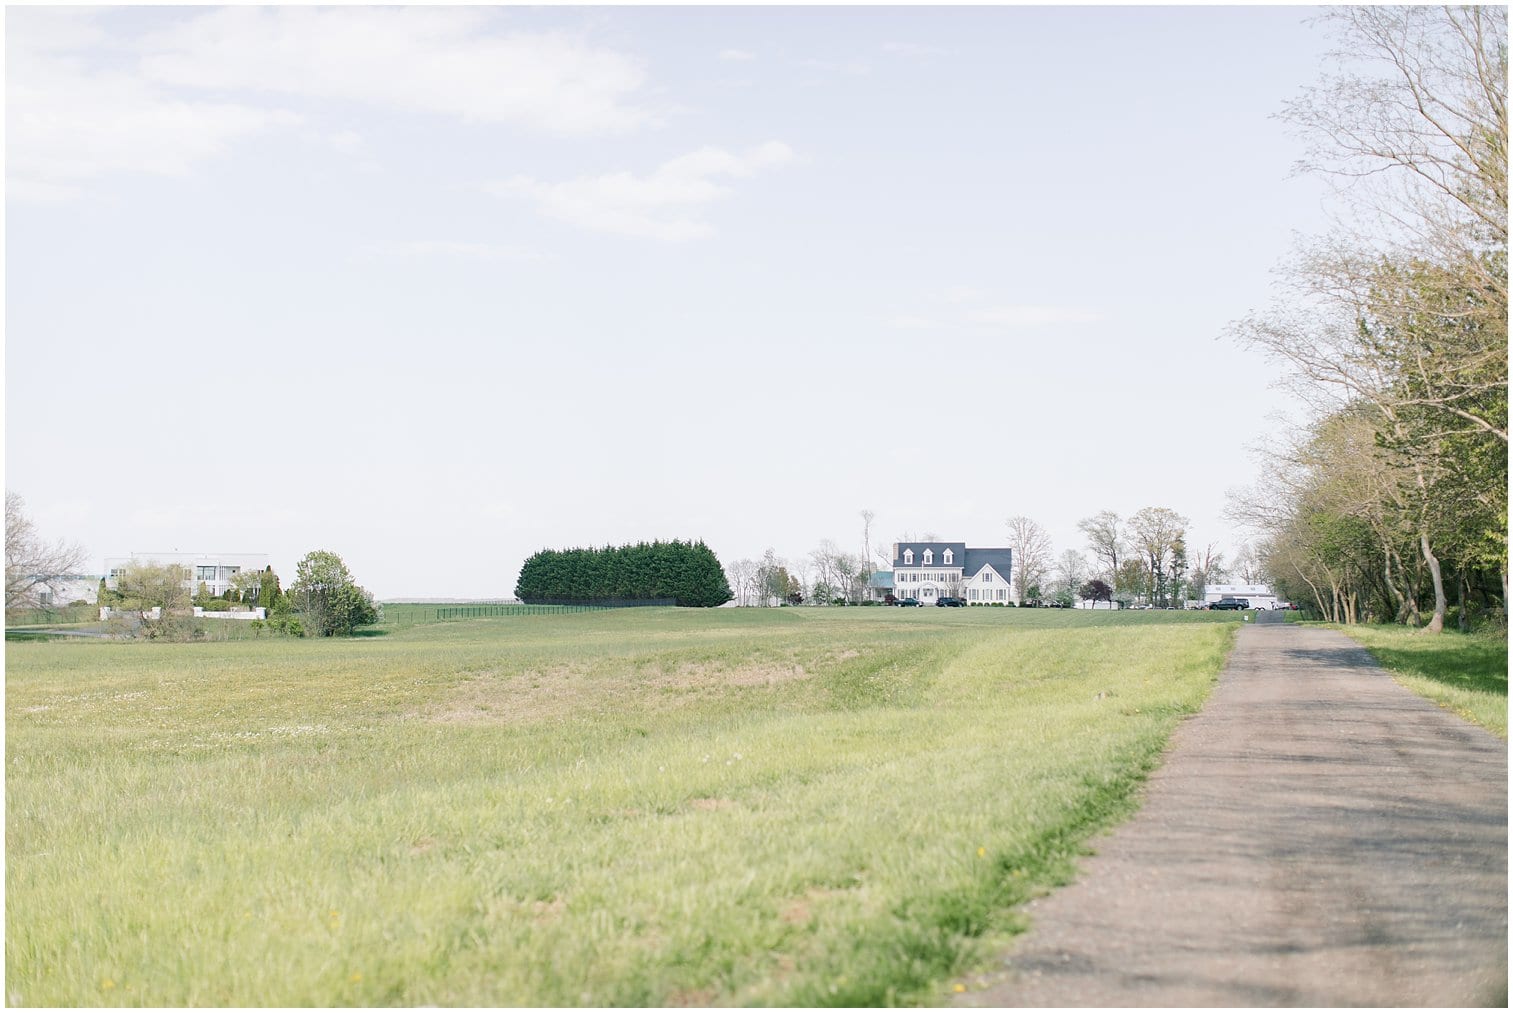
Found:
[486,141,793,242]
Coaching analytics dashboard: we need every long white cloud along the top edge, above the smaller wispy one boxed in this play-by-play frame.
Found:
[142,8,655,135]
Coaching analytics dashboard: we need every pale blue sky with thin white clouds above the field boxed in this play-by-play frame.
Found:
[5,6,1331,600]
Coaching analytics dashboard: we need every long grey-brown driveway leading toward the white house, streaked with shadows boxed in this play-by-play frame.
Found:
[955,623,1508,1005]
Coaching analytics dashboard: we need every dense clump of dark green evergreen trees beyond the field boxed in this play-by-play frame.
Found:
[514,541,734,608]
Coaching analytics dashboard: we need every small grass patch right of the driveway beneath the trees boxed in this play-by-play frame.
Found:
[1336,626,1508,739]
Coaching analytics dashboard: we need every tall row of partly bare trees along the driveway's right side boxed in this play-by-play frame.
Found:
[1235,6,1508,632]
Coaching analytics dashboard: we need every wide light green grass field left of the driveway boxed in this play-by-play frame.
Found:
[6,609,1239,1005]
